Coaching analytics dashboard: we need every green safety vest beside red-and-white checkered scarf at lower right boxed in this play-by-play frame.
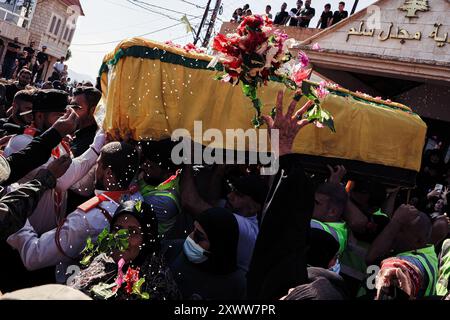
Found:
[396,245,438,297]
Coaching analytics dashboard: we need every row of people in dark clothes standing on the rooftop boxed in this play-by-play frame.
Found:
[231,0,348,29]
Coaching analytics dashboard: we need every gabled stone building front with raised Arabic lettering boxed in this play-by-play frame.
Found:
[297,0,450,123]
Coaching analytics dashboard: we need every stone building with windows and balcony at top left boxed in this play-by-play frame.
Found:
[0,0,84,79]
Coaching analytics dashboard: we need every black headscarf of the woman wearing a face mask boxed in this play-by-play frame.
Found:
[196,208,239,274]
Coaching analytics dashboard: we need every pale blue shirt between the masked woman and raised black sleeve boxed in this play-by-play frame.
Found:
[234,214,259,272]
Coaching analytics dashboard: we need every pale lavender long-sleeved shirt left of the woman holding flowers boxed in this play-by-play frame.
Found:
[7,193,143,283]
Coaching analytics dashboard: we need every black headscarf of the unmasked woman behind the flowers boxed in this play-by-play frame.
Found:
[111,201,160,265]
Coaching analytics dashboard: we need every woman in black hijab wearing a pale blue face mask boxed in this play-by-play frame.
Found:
[167,208,246,300]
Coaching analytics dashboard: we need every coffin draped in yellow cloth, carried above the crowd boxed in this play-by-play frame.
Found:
[100,38,427,184]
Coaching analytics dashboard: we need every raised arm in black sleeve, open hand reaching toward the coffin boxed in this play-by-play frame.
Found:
[247,92,314,300]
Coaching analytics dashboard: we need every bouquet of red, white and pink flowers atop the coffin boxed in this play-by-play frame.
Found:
[208,15,334,131]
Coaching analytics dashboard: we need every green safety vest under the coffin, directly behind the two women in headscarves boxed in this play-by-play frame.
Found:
[138,174,181,234]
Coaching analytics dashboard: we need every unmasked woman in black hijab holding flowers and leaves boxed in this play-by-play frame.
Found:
[70,201,181,300]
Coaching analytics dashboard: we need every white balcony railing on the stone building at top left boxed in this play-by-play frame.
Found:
[0,0,36,29]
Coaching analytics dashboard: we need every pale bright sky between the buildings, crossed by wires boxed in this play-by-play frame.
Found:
[68,0,375,80]
